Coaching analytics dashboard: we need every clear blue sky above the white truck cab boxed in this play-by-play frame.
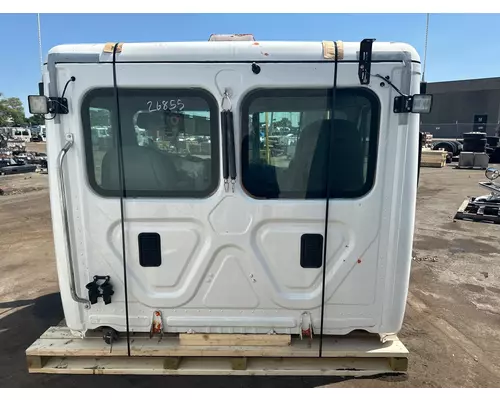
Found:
[0,14,500,114]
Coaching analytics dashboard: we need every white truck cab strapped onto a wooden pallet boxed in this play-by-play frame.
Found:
[30,38,432,335]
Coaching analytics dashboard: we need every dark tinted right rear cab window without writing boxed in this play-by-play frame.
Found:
[242,89,380,199]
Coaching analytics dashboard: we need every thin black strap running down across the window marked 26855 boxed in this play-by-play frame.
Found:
[113,43,130,357]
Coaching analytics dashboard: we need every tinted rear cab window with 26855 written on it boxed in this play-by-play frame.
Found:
[82,89,219,197]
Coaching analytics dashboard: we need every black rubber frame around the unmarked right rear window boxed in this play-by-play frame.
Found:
[239,87,382,201]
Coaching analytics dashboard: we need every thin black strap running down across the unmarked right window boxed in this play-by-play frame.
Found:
[320,42,339,358]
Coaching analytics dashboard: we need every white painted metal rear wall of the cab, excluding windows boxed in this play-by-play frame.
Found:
[47,42,420,340]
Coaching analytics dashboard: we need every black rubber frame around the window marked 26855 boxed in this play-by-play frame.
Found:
[80,87,221,200]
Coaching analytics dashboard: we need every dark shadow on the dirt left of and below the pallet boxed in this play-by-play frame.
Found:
[0,293,392,388]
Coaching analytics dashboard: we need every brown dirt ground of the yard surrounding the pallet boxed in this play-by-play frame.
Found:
[0,166,500,387]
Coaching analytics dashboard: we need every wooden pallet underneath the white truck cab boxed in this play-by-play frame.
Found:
[26,326,408,376]
